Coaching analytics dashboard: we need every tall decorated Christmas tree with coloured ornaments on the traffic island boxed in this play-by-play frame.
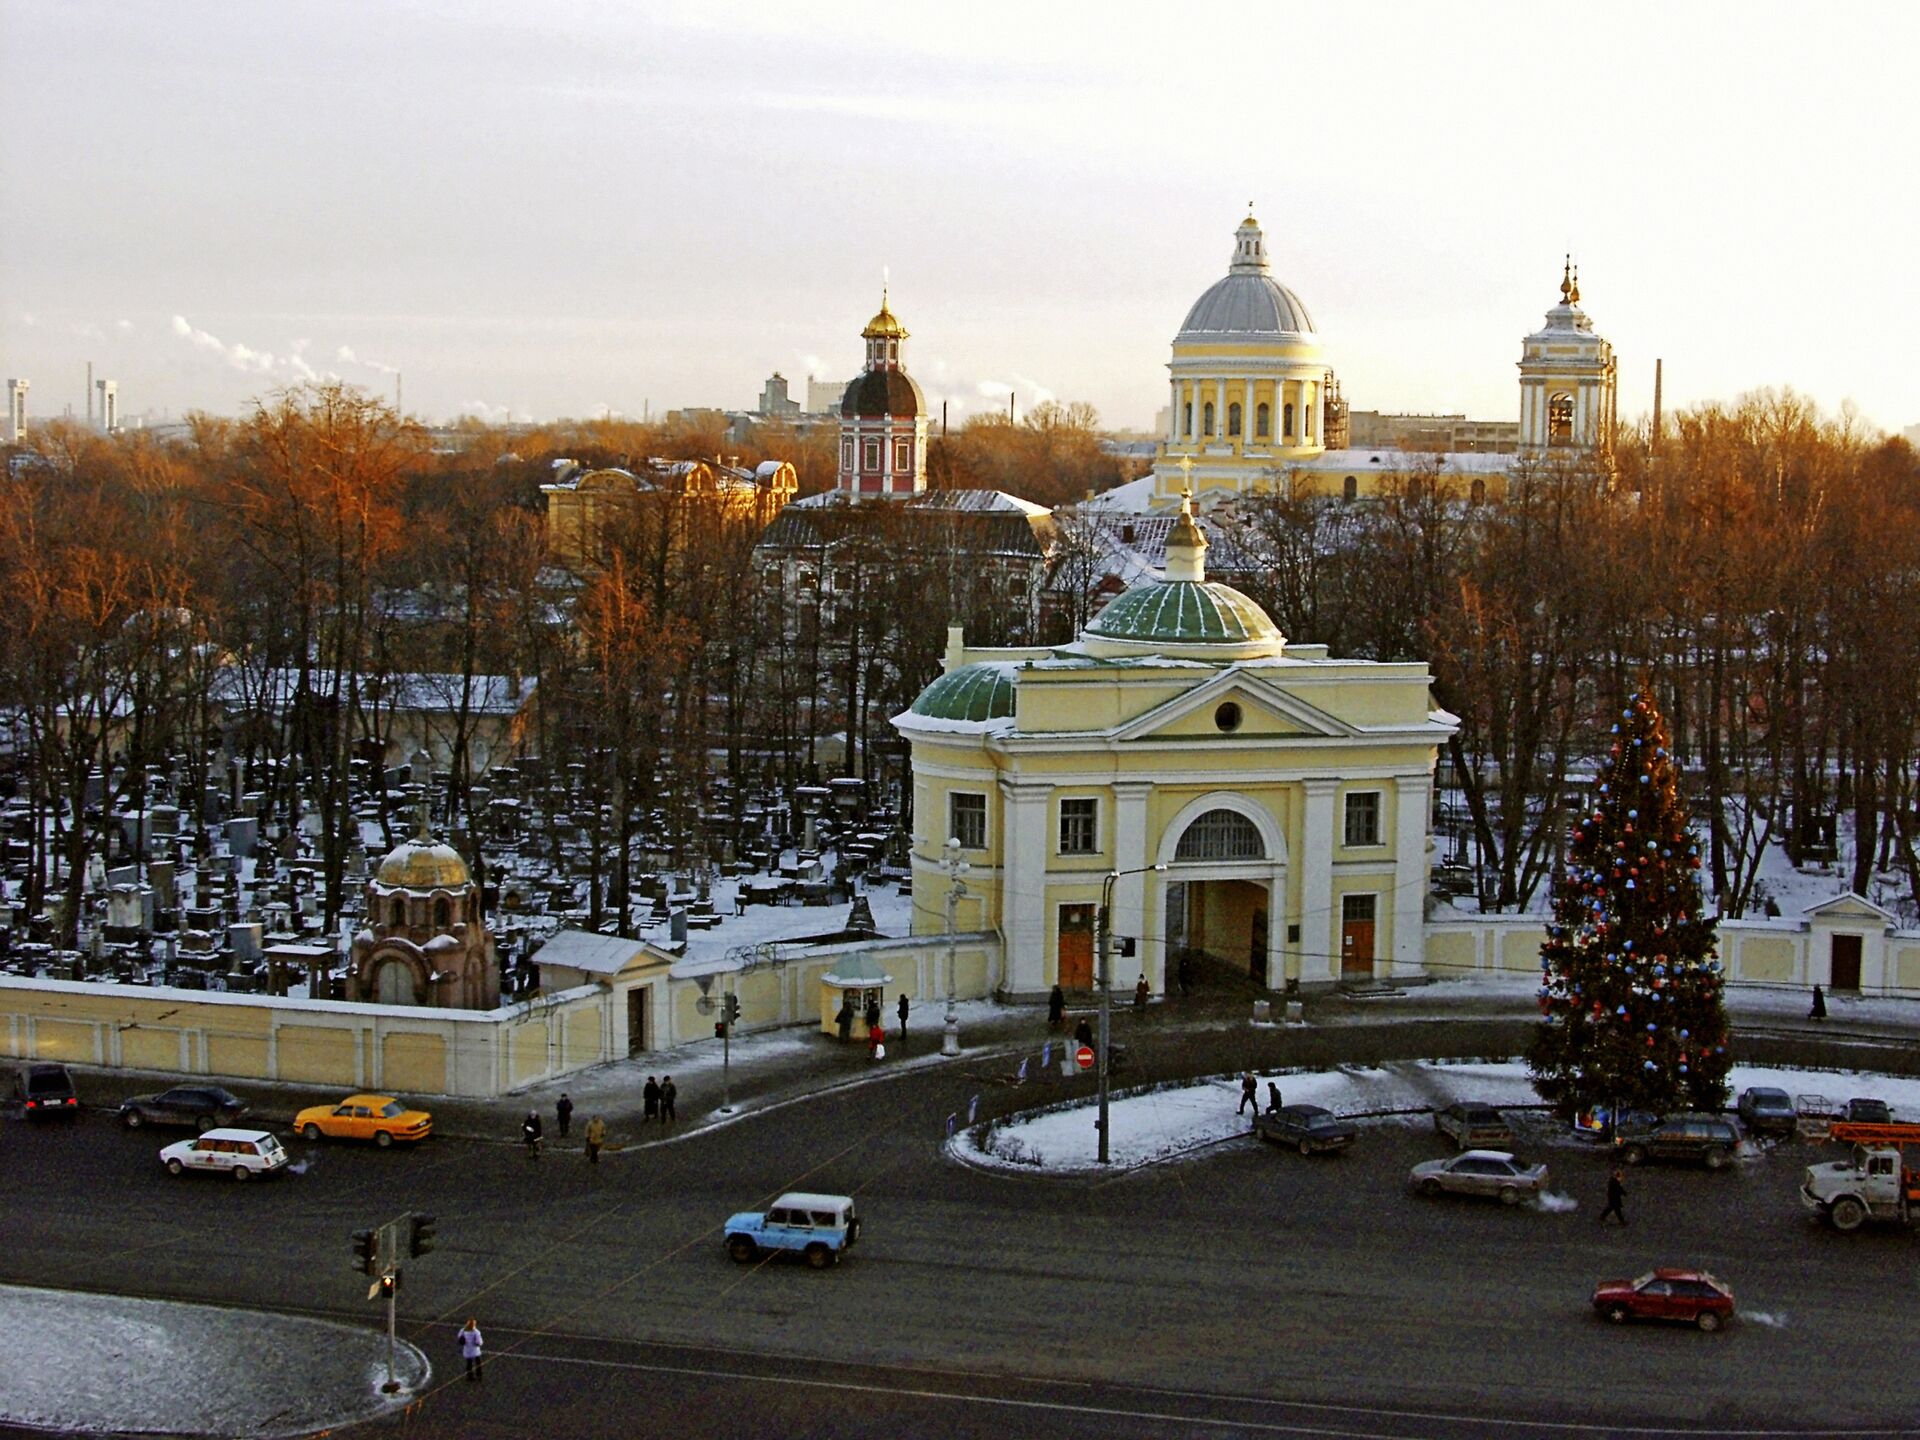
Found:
[1528,693,1732,1116]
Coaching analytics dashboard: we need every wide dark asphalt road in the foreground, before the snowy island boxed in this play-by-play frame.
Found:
[0,1071,1920,1440]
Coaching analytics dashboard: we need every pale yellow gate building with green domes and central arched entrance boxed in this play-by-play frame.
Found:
[893,495,1457,998]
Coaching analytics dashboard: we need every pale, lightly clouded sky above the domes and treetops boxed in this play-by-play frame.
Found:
[0,0,1920,430]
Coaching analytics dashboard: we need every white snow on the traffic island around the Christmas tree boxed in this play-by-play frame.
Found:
[948,1060,1920,1175]
